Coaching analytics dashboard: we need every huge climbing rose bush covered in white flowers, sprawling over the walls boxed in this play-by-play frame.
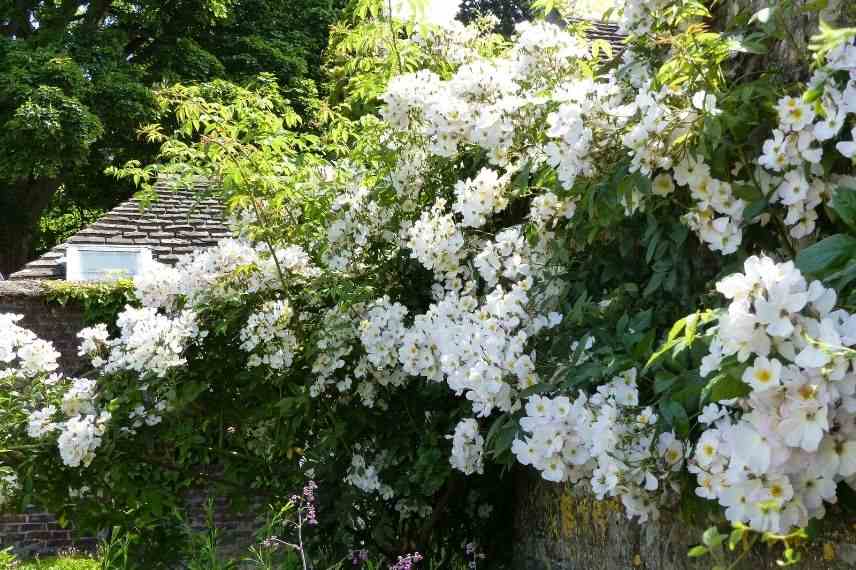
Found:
[0,0,856,552]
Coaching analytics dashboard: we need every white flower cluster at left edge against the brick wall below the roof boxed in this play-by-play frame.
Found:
[0,313,60,378]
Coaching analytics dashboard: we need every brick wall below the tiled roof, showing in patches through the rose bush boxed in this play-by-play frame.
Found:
[0,281,261,556]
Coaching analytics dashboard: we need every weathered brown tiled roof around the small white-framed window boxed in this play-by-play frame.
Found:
[9,175,230,279]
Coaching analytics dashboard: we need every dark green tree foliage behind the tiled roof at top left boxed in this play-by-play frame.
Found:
[0,0,345,274]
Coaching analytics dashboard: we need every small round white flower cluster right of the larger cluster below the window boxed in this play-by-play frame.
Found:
[240,299,297,370]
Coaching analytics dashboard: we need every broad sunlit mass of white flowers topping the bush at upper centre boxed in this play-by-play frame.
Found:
[382,22,595,166]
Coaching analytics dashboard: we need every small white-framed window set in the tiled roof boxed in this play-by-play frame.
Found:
[65,245,152,281]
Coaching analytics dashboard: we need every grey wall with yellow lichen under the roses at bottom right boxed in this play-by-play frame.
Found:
[512,468,856,570]
